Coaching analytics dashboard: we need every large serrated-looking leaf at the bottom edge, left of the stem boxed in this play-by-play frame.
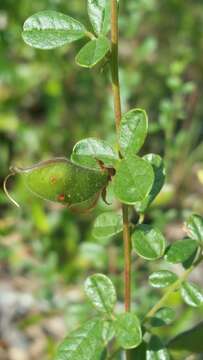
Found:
[55,319,104,360]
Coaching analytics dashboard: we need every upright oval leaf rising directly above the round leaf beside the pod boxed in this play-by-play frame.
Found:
[119,109,148,156]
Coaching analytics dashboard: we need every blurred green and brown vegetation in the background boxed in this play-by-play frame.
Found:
[0,0,203,360]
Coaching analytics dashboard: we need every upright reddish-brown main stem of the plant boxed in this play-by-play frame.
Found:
[111,0,131,360]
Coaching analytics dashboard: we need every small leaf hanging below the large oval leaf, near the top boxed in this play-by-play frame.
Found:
[76,37,110,68]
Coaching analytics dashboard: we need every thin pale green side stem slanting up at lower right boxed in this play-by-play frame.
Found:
[144,254,203,322]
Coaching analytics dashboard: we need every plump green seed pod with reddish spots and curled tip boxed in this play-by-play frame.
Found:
[5,158,109,209]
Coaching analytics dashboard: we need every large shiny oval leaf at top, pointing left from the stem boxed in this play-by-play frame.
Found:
[22,10,86,50]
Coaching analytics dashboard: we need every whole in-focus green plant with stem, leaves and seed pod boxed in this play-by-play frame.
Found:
[4,0,203,360]
